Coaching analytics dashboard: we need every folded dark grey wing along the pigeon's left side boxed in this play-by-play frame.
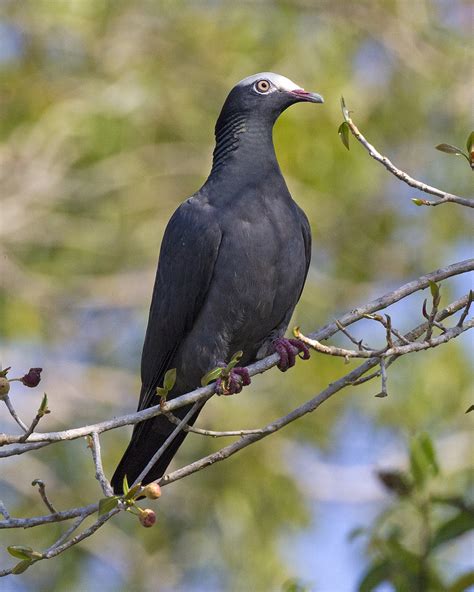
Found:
[138,198,222,410]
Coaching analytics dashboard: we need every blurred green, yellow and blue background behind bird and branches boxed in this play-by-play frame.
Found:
[0,0,473,592]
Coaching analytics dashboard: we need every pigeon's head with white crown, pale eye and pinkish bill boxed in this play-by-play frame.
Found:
[218,72,324,123]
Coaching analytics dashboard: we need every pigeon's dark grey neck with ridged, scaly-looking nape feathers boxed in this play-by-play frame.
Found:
[209,113,280,180]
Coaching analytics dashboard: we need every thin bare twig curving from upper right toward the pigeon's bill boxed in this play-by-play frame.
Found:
[341,100,474,208]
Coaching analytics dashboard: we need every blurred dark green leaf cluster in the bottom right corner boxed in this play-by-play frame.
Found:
[358,433,474,592]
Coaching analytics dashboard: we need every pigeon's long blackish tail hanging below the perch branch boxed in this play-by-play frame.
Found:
[111,406,202,495]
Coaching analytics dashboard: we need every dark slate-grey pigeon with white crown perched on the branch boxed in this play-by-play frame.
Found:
[111,72,324,494]
